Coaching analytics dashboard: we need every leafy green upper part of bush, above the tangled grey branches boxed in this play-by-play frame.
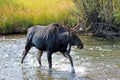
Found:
[74,0,120,24]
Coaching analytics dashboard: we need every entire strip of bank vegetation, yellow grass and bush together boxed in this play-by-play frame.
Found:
[0,0,120,38]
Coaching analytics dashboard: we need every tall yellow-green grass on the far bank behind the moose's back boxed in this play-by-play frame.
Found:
[0,0,74,34]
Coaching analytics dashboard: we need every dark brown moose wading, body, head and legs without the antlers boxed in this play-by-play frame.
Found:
[21,23,83,73]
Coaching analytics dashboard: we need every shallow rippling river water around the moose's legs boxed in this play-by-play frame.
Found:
[0,35,120,80]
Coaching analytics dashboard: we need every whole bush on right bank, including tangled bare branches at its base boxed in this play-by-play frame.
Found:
[74,0,120,39]
